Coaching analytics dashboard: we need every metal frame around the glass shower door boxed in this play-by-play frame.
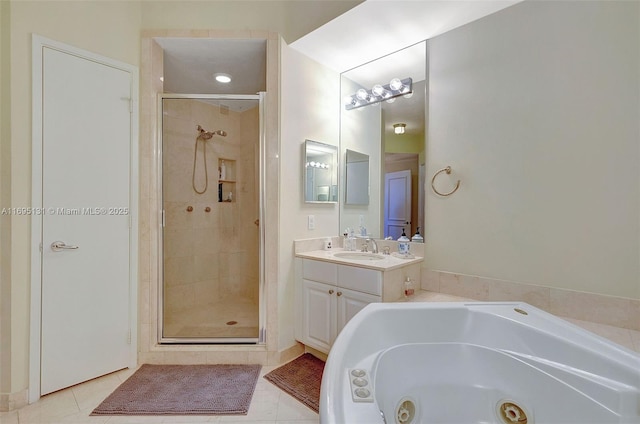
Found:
[156,92,267,345]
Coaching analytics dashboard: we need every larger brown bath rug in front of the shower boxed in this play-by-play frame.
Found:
[91,364,261,415]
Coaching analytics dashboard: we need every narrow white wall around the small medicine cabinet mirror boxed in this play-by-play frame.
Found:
[278,42,342,349]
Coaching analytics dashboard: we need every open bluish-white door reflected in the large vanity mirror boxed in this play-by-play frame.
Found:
[384,170,411,240]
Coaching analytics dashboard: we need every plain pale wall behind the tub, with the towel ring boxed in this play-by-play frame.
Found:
[426,2,640,299]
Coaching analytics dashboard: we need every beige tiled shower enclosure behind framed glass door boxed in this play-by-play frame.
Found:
[158,93,265,343]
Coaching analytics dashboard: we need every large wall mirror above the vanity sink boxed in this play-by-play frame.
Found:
[339,41,427,238]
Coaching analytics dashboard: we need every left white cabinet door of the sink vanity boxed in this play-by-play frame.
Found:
[302,280,336,353]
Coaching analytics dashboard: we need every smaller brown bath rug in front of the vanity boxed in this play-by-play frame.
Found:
[264,353,324,412]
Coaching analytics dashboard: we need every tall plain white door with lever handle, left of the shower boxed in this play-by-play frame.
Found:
[40,47,132,394]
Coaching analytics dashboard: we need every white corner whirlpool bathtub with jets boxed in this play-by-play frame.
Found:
[320,302,640,424]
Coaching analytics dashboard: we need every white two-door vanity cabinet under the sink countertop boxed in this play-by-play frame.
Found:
[296,259,382,353]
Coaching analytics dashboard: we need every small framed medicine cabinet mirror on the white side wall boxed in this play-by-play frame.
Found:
[303,140,338,203]
